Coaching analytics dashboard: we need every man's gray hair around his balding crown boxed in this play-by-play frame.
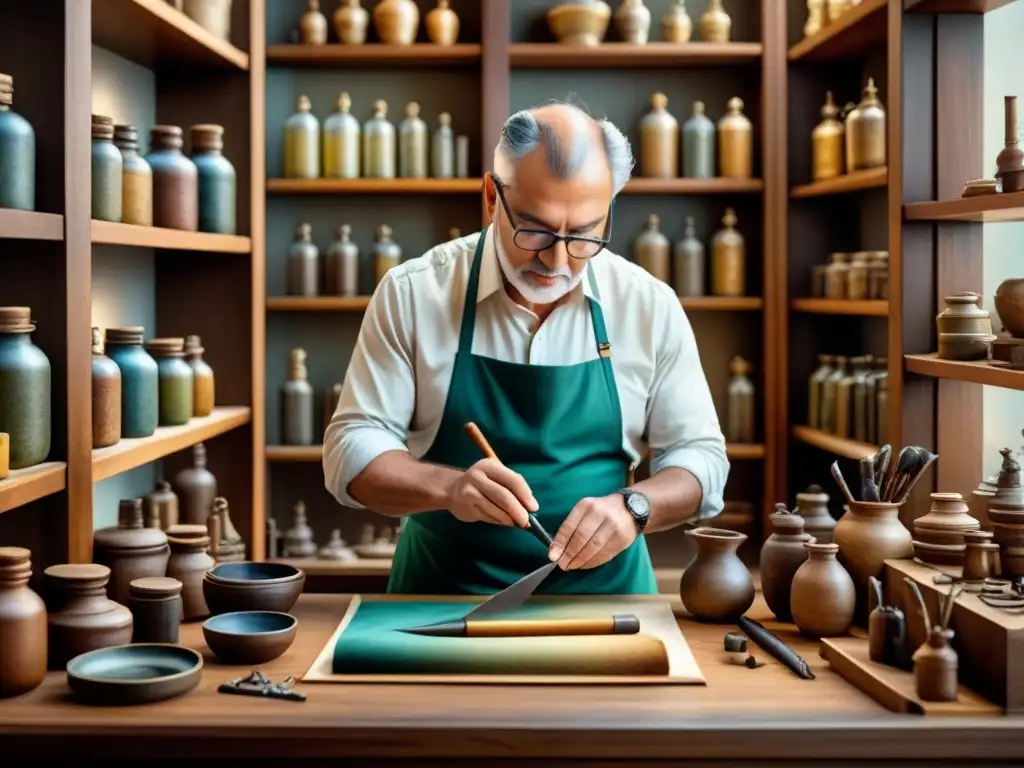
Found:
[495,101,633,197]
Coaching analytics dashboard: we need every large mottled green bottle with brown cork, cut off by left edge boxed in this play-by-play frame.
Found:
[0,306,50,469]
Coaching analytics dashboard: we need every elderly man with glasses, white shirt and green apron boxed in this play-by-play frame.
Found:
[324,103,729,594]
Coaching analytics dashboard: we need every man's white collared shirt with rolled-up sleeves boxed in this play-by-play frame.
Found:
[324,230,729,517]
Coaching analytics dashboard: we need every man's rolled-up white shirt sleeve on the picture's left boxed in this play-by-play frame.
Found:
[324,272,416,507]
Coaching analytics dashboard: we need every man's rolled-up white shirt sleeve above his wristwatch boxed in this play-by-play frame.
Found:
[647,288,729,520]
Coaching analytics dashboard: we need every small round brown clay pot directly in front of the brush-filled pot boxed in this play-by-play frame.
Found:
[790,542,857,637]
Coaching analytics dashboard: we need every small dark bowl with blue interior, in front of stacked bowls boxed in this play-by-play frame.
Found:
[203,610,299,664]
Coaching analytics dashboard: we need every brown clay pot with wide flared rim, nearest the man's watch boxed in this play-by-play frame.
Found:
[679,527,754,624]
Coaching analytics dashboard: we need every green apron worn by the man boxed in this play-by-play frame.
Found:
[387,229,657,595]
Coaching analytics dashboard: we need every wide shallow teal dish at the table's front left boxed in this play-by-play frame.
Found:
[68,643,203,707]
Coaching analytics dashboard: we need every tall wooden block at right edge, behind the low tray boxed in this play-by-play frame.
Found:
[885,560,1024,715]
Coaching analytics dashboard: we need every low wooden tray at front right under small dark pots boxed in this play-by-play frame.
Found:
[818,637,1002,717]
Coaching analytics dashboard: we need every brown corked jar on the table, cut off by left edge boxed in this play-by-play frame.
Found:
[0,547,47,698]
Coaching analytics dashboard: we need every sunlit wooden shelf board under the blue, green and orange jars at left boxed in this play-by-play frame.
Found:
[92,406,252,482]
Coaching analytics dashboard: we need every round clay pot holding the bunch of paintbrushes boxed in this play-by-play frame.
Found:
[833,502,913,622]
